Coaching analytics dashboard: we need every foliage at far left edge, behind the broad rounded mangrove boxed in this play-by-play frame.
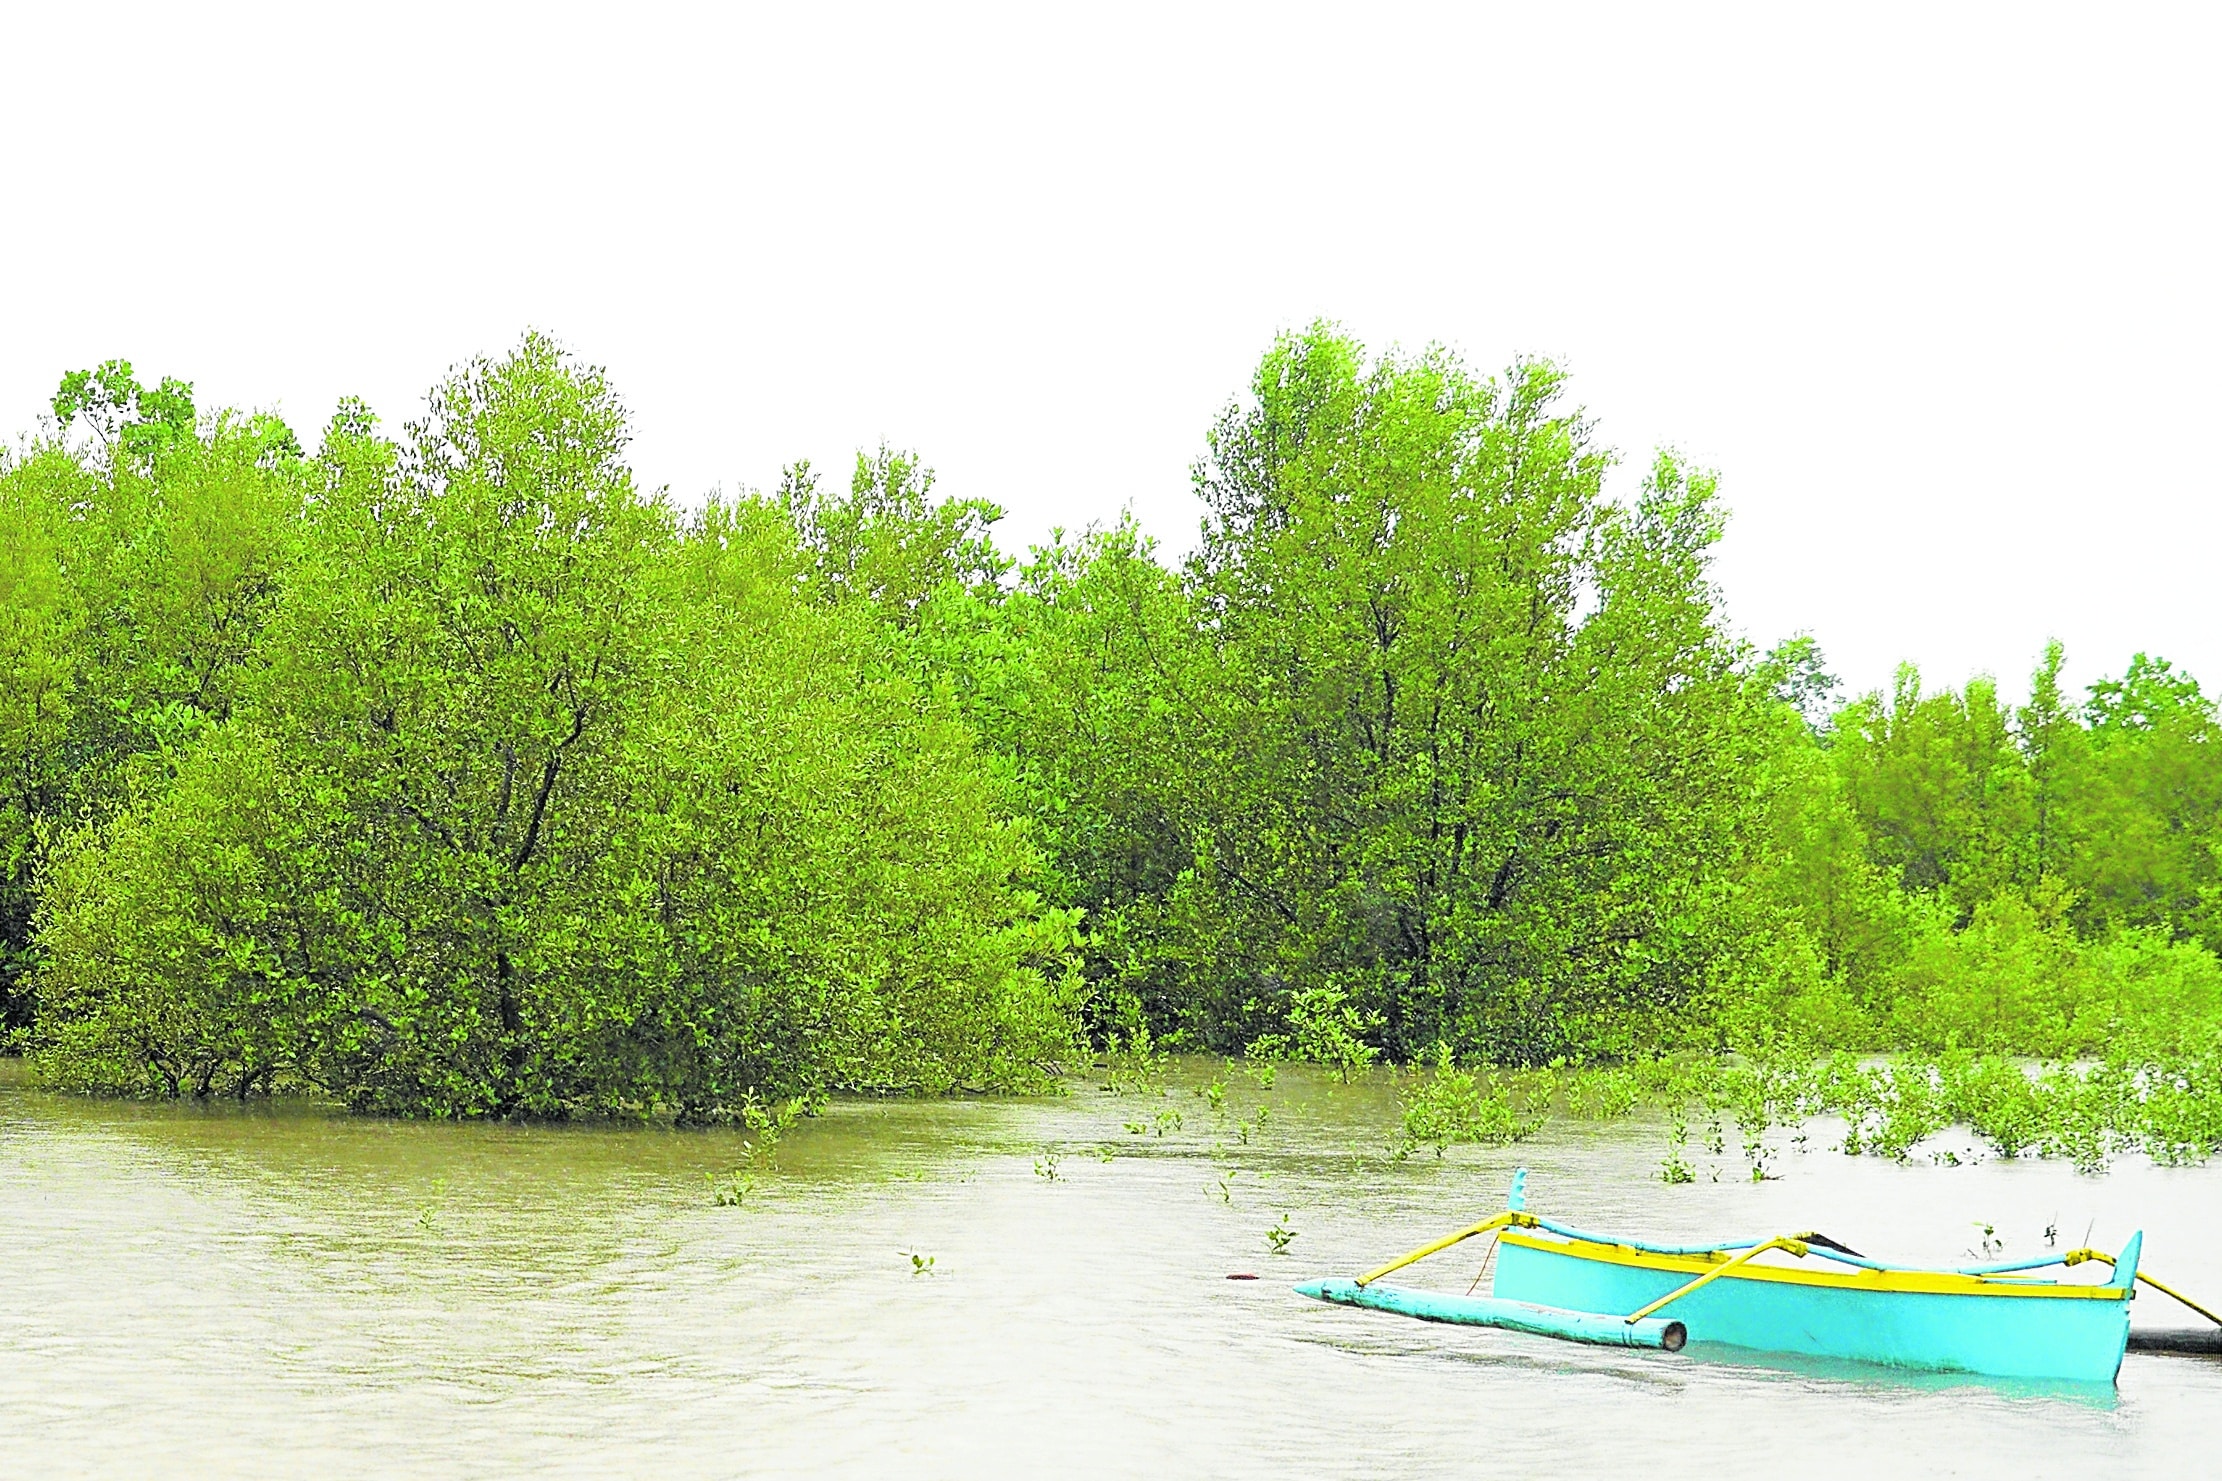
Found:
[0,362,307,1035]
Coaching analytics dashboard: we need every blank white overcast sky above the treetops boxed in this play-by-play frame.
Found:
[0,2,2222,706]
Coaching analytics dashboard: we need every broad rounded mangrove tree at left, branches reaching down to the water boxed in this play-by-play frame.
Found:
[23,337,1075,1119]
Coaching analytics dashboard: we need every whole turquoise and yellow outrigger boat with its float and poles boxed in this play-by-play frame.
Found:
[1295,1168,2222,1383]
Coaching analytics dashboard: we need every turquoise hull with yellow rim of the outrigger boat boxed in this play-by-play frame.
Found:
[1493,1232,2129,1383]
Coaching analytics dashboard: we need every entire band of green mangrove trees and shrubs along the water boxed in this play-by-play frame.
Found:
[0,326,2222,1172]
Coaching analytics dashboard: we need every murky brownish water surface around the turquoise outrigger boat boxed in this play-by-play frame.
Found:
[13,1066,2222,1481]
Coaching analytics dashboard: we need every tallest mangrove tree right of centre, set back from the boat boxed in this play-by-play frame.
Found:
[942,326,1751,1066]
